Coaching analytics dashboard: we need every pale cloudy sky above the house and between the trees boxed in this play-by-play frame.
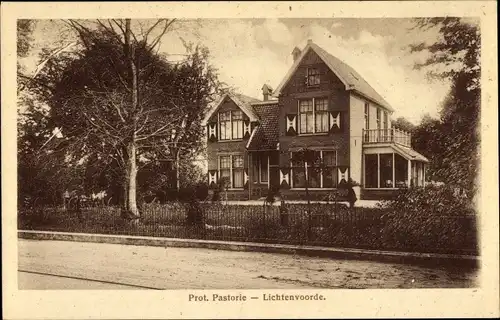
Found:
[23,18,458,124]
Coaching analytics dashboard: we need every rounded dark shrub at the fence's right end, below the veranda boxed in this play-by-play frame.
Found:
[381,186,477,251]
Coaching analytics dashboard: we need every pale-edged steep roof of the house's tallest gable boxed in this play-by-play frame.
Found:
[273,42,394,112]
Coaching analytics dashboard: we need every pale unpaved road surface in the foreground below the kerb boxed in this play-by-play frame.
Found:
[18,239,478,289]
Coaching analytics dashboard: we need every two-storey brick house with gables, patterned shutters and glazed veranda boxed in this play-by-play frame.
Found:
[203,40,428,200]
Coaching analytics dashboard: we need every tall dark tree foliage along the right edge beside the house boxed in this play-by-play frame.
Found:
[411,17,481,198]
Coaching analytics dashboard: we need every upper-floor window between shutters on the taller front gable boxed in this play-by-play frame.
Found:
[299,98,330,134]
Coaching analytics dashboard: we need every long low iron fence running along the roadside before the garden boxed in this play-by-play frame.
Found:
[18,203,478,254]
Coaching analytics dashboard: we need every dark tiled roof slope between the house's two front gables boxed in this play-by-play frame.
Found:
[247,101,279,150]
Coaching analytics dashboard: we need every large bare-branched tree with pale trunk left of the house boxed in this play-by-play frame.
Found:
[24,19,219,219]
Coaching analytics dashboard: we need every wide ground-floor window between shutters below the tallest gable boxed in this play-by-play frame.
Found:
[291,150,337,188]
